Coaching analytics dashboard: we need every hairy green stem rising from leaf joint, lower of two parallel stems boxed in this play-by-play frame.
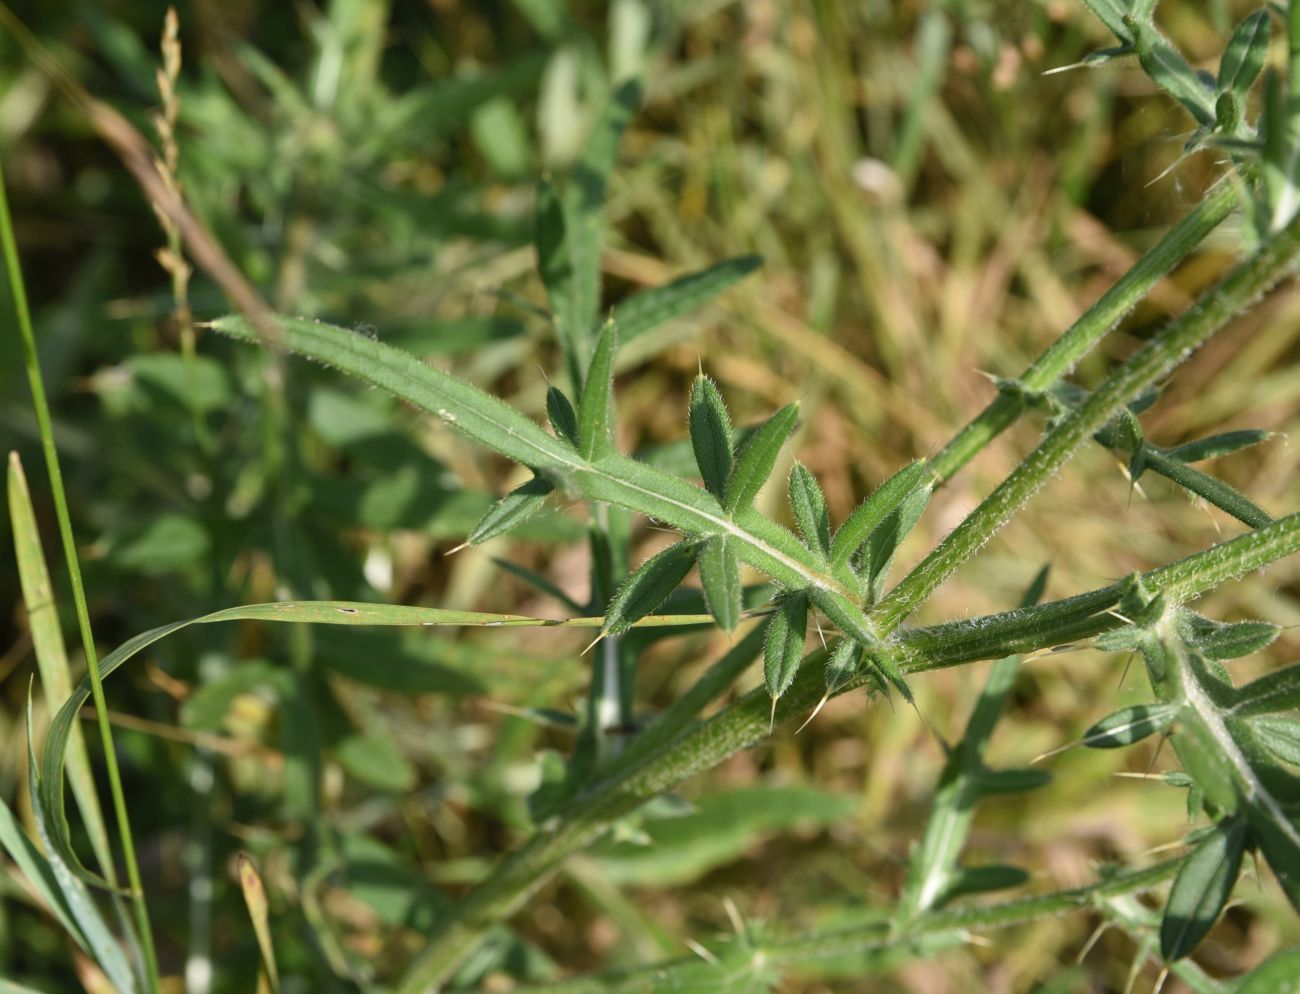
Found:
[870,202,1300,634]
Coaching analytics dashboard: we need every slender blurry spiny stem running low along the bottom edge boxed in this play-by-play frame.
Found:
[462,859,1183,994]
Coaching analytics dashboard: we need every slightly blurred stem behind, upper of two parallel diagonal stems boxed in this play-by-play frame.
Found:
[931,175,1242,481]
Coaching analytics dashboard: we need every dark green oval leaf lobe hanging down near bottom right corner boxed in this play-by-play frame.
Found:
[1160,819,1245,963]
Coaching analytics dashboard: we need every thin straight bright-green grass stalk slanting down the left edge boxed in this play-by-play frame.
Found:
[0,166,159,991]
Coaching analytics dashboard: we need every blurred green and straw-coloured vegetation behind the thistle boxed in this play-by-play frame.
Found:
[0,0,1300,994]
